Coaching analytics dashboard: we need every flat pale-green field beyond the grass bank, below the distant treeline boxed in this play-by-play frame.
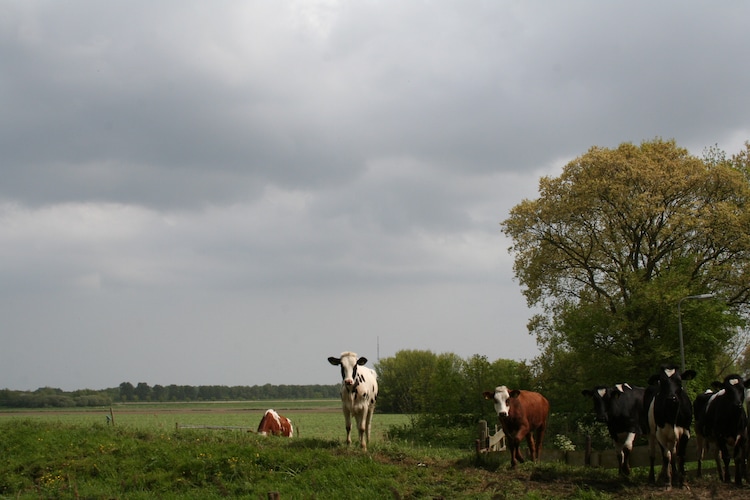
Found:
[0,399,409,441]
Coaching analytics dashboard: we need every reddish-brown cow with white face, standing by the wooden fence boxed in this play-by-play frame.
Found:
[482,385,549,467]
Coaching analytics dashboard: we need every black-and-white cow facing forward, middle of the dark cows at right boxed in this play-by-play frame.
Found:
[648,365,696,489]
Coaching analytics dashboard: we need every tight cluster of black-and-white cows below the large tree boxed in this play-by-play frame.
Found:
[582,365,750,487]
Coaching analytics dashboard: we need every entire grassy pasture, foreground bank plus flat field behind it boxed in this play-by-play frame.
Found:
[0,400,750,500]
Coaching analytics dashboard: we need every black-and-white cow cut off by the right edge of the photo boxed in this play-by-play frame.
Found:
[694,374,748,486]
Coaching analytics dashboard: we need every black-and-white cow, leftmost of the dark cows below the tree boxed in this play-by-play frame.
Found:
[581,384,648,476]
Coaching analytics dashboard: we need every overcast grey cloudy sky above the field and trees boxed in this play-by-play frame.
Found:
[0,0,750,390]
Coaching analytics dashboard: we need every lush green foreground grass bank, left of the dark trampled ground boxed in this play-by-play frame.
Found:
[0,418,482,498]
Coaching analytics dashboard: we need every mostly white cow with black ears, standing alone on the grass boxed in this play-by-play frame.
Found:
[328,351,378,450]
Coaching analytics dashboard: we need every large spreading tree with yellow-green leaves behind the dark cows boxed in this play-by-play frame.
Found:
[502,139,750,406]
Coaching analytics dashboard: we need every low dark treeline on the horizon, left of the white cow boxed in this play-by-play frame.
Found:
[0,382,341,408]
